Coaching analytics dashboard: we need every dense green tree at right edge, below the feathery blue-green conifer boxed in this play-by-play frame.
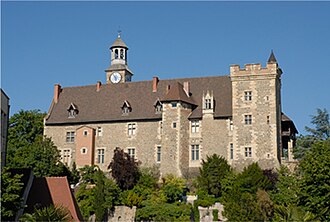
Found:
[299,140,330,221]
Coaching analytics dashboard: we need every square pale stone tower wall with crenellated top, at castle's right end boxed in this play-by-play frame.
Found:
[230,64,281,169]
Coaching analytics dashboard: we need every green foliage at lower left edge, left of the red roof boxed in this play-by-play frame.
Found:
[1,168,23,221]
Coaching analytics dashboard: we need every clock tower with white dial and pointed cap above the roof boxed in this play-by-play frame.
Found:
[105,32,133,84]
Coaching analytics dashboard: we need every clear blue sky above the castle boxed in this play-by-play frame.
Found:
[1,1,330,134]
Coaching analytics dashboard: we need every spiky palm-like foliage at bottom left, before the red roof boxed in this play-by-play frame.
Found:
[20,205,73,222]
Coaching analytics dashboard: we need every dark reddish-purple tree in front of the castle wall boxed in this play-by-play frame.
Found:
[108,147,140,190]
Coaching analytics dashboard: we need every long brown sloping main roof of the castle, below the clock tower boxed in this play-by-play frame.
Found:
[46,76,232,125]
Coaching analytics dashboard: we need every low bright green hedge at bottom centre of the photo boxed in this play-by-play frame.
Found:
[135,203,192,221]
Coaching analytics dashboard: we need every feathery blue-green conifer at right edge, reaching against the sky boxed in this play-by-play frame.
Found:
[293,109,330,159]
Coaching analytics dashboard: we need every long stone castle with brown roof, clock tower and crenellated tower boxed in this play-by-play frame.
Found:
[44,35,297,176]
